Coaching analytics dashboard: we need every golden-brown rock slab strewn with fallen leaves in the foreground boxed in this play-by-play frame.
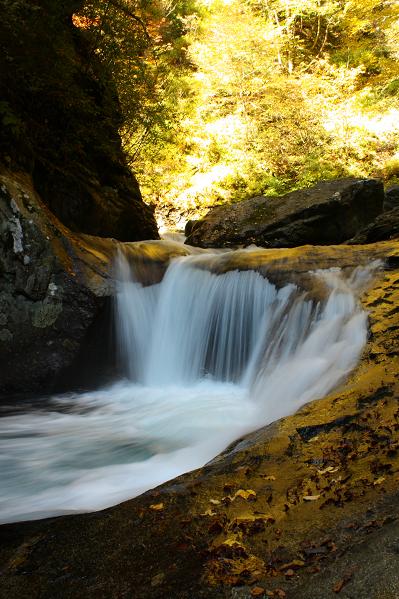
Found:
[0,237,399,599]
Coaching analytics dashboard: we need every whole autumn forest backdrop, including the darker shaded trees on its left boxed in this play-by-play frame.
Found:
[73,0,399,225]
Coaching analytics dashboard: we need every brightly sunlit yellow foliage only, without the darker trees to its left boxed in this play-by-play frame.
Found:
[124,0,399,225]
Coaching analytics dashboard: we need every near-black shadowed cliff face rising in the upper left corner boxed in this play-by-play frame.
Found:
[0,0,158,241]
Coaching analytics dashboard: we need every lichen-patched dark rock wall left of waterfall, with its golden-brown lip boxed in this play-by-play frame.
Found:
[0,172,193,394]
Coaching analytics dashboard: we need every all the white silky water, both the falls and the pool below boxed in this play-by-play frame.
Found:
[0,246,375,522]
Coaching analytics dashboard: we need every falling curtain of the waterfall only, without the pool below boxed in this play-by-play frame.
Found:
[117,254,376,422]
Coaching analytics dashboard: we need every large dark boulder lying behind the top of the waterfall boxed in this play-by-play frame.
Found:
[186,179,384,248]
